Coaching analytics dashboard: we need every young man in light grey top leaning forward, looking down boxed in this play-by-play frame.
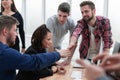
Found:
[47,2,75,51]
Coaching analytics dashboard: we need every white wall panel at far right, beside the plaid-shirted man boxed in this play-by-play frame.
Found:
[108,0,120,42]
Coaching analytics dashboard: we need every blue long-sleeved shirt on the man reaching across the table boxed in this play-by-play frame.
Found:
[0,42,60,80]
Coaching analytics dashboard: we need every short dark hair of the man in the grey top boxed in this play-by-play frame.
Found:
[58,2,70,14]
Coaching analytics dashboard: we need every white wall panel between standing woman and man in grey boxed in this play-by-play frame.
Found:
[26,0,44,35]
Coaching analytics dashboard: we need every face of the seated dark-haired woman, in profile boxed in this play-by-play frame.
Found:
[42,32,52,48]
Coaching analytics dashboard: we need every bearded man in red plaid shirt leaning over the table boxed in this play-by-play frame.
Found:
[64,1,113,64]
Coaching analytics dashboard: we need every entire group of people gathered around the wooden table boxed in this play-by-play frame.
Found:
[0,0,120,80]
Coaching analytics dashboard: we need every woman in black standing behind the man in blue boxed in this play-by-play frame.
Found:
[0,0,25,53]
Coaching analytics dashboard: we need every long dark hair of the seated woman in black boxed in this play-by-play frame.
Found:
[31,24,51,51]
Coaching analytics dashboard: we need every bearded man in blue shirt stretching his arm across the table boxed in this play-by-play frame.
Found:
[0,16,70,80]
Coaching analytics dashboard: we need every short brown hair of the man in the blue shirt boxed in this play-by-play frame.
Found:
[0,15,19,33]
